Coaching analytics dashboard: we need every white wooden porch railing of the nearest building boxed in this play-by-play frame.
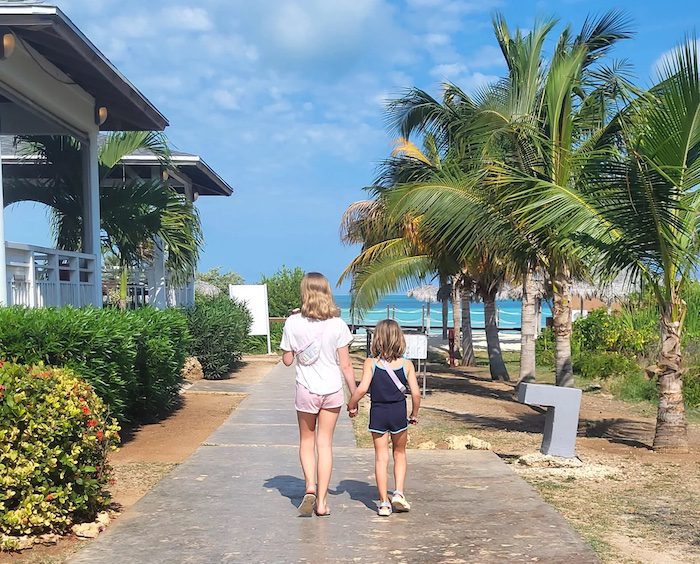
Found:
[5,242,97,307]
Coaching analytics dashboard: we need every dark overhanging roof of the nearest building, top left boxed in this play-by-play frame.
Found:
[0,1,168,131]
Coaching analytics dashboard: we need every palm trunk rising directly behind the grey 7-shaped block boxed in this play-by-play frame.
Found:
[552,268,574,388]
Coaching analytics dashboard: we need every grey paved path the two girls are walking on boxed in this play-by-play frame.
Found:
[73,365,597,564]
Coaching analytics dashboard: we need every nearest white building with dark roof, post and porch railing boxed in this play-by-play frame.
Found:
[0,2,168,306]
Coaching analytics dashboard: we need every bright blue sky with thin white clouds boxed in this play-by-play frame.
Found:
[5,0,700,288]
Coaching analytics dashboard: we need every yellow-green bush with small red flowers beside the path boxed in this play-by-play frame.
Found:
[0,363,119,546]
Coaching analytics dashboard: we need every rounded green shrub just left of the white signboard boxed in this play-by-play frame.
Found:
[187,296,252,379]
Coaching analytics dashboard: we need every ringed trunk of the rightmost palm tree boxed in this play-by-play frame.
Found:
[650,299,688,453]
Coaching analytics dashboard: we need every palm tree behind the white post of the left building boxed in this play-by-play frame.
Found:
[5,132,202,307]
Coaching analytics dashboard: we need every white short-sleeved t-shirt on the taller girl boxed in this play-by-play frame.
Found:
[280,313,352,395]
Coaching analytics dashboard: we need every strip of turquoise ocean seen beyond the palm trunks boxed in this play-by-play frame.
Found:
[335,294,551,334]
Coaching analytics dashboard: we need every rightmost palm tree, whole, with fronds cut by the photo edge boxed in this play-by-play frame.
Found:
[521,38,700,452]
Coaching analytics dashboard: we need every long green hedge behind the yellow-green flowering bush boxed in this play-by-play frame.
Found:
[0,307,189,422]
